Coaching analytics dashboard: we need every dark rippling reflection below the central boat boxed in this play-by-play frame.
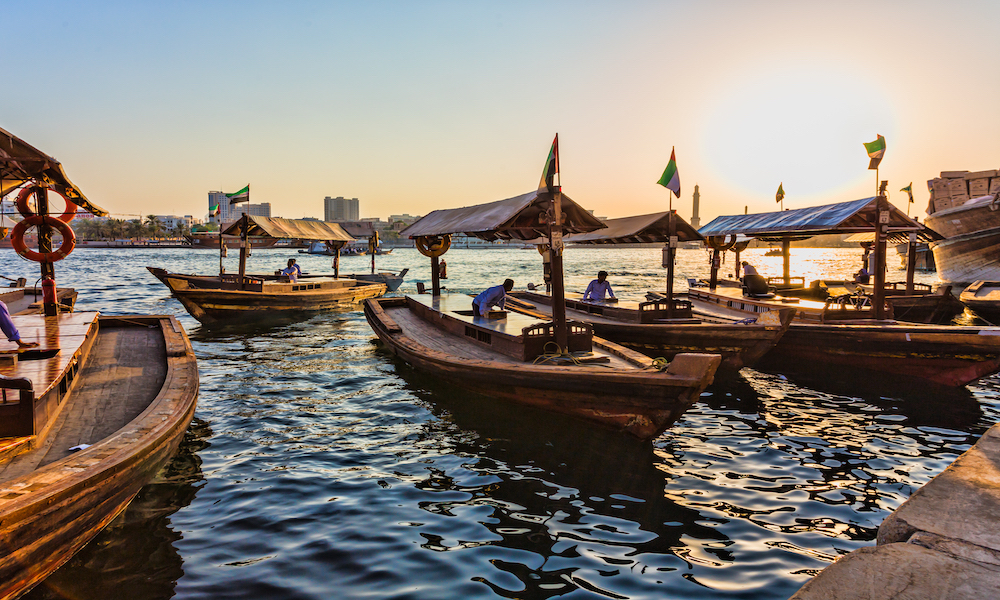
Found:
[398,365,733,598]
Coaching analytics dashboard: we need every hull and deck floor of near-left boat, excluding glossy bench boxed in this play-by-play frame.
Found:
[0,316,198,600]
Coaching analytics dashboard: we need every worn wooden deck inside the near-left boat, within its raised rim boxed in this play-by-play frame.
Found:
[0,313,167,484]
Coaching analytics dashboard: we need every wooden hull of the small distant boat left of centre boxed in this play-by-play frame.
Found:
[147,267,386,325]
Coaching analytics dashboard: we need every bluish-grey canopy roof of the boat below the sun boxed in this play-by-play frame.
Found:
[698,197,924,241]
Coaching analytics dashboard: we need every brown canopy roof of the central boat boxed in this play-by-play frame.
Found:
[400,191,605,241]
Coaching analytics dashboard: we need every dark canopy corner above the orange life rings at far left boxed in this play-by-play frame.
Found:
[0,129,108,217]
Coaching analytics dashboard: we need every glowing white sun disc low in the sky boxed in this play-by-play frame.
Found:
[701,67,895,207]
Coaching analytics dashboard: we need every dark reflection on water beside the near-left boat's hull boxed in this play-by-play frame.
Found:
[25,418,212,600]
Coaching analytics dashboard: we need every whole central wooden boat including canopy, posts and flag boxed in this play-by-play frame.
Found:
[376,150,721,439]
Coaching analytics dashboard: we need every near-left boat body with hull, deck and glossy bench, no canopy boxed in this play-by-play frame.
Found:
[0,312,198,599]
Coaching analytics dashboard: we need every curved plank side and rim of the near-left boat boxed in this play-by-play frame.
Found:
[0,315,198,600]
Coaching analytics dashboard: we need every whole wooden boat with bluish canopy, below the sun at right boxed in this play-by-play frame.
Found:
[688,195,1000,386]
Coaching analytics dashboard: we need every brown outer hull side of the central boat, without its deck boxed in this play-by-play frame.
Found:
[365,298,721,439]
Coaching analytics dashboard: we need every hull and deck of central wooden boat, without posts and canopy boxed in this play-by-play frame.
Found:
[365,295,721,439]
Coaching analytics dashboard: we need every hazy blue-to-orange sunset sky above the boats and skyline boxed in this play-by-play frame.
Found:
[0,0,1000,223]
